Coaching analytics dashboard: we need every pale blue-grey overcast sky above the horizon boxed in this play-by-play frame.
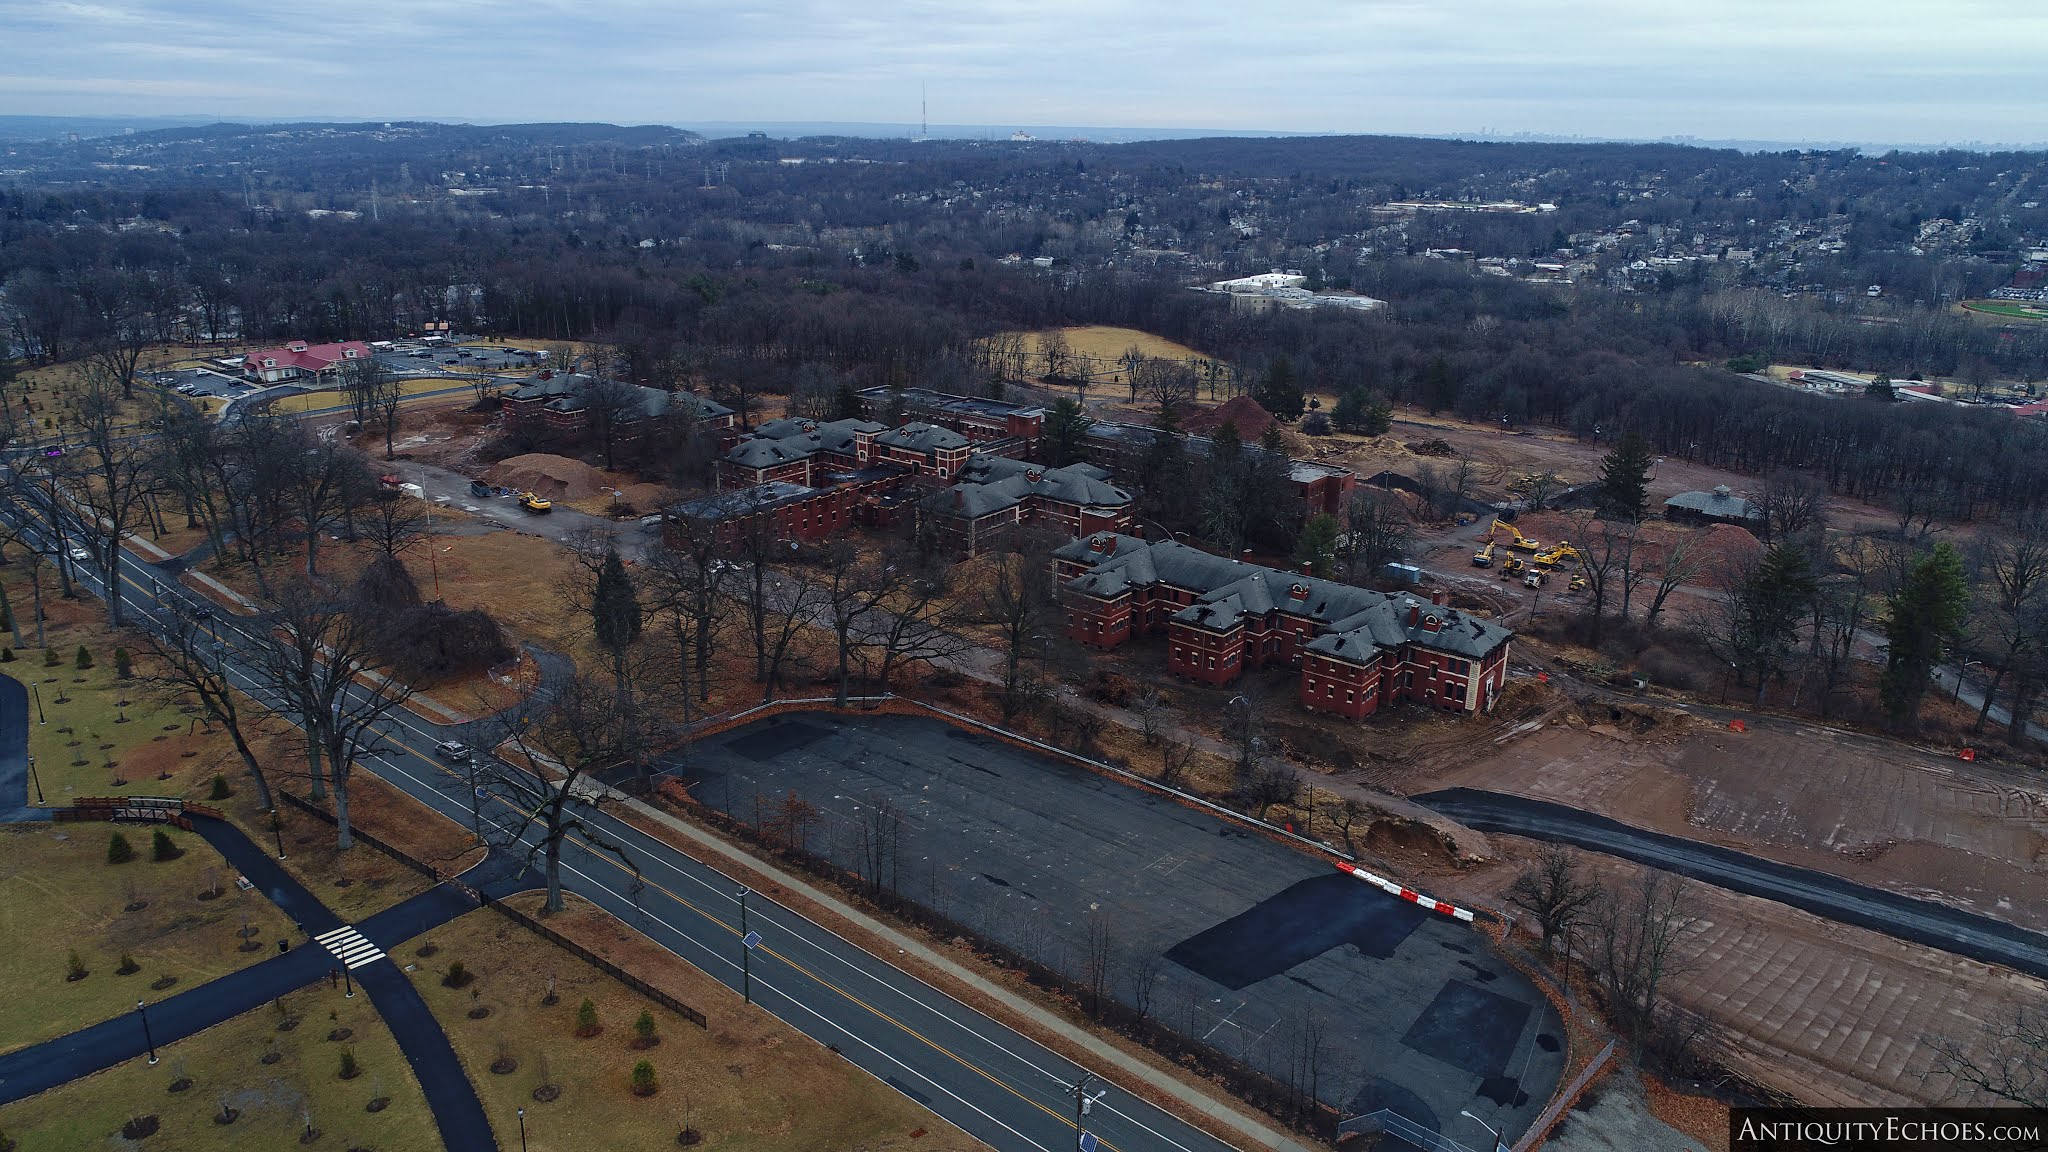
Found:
[0,0,2048,141]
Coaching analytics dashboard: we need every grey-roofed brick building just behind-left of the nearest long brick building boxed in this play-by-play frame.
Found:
[924,453,1135,558]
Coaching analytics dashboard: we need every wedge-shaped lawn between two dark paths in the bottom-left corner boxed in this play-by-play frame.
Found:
[0,984,444,1152]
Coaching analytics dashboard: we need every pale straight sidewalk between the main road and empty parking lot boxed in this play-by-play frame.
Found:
[623,797,1309,1152]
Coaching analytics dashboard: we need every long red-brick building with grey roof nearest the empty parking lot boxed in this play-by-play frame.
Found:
[1053,533,1513,719]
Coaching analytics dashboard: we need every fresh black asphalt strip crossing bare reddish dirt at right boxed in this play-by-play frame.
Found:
[1415,787,2048,980]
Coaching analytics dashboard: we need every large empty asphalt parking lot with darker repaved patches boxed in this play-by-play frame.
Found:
[672,713,1563,1148]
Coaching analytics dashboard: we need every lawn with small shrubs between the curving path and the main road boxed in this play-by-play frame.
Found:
[409,896,981,1152]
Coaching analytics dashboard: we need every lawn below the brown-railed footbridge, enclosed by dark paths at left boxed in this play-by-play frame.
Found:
[0,824,291,1052]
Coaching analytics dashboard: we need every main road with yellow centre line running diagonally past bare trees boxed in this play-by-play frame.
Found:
[8,481,1229,1152]
